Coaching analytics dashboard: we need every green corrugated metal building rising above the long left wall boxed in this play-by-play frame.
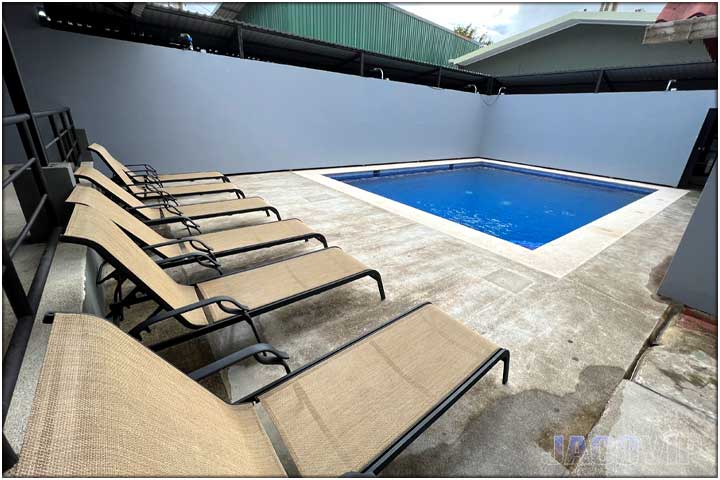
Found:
[236,3,478,67]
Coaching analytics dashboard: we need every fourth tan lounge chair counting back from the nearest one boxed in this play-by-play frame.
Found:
[75,165,280,233]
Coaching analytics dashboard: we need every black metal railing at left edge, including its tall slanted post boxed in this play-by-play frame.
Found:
[2,20,83,472]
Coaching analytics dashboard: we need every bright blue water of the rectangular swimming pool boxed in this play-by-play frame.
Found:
[329,163,654,250]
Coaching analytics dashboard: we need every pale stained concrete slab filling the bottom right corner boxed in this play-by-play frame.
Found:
[574,380,717,477]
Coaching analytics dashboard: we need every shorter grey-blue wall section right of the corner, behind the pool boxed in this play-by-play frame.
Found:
[479,91,717,186]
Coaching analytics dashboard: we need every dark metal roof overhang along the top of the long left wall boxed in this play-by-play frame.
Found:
[38,2,489,91]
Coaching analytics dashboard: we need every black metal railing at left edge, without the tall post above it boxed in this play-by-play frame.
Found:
[2,109,64,471]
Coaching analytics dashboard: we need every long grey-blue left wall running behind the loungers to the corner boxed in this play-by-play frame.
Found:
[3,4,483,173]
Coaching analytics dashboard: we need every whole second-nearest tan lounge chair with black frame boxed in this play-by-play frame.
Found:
[60,205,385,350]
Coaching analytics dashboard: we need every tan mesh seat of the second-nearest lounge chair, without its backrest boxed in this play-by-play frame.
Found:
[197,248,368,316]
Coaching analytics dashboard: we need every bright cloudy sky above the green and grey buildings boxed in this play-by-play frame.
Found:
[395,3,665,42]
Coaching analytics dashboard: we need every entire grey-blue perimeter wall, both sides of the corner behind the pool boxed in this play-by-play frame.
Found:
[3,4,717,186]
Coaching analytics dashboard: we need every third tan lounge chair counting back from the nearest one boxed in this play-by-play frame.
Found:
[66,185,328,274]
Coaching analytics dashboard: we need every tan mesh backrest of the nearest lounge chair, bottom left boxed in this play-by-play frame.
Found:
[15,314,285,477]
